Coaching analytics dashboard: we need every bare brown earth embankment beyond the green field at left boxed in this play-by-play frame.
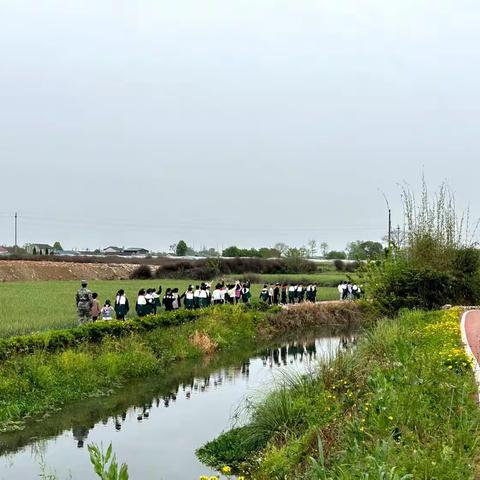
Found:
[0,260,147,282]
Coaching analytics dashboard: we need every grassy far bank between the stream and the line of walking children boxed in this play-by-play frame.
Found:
[0,305,360,431]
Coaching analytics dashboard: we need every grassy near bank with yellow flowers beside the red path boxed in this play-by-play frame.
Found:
[199,310,480,480]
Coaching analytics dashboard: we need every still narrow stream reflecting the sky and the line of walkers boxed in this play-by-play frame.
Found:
[0,332,350,480]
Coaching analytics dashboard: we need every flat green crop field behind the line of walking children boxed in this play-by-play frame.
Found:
[0,275,337,337]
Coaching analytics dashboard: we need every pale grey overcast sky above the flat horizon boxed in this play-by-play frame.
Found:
[0,0,480,250]
